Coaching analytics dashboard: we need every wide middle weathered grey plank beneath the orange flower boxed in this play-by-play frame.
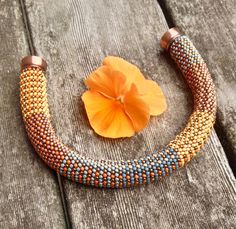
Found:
[26,0,236,228]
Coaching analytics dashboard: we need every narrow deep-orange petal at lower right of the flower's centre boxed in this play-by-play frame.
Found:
[124,84,150,131]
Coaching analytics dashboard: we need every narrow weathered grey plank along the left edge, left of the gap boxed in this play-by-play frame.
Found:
[0,1,65,228]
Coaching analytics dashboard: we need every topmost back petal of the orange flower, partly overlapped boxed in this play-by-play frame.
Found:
[103,56,145,88]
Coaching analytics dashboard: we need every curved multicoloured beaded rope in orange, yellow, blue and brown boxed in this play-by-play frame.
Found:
[20,28,216,188]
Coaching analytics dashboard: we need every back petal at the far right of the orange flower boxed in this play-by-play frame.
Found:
[135,80,167,115]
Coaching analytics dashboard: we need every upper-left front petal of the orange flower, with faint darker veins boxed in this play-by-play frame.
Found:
[85,66,126,98]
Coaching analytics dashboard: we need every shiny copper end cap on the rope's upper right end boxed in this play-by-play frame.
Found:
[160,27,182,51]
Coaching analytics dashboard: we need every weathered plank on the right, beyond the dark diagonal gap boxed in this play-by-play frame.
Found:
[165,0,236,174]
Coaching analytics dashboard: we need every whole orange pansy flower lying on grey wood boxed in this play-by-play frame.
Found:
[82,56,166,138]
